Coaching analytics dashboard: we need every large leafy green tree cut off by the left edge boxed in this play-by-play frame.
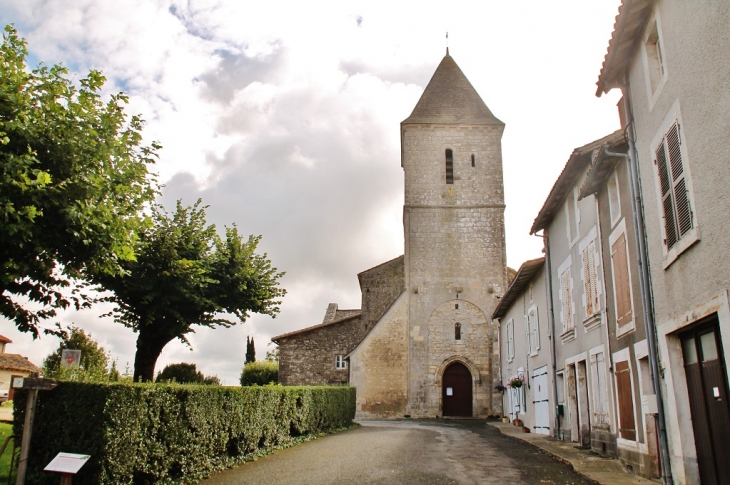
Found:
[0,26,159,337]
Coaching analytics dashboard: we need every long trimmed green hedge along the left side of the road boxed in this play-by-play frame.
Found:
[14,382,355,485]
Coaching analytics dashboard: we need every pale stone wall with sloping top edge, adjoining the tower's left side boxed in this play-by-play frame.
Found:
[350,293,408,419]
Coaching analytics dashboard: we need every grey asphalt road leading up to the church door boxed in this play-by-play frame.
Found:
[201,419,595,485]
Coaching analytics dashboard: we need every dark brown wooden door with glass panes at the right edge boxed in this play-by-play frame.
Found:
[681,317,730,485]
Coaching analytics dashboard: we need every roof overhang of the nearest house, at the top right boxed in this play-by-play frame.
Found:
[596,0,656,96]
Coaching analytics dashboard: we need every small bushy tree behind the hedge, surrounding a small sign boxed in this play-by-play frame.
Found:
[43,325,109,377]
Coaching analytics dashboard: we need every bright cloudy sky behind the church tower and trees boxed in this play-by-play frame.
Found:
[0,0,620,385]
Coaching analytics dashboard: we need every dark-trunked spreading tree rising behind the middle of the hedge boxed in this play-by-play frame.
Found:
[96,200,286,381]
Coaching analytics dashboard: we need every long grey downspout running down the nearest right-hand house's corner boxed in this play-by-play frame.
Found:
[604,89,673,478]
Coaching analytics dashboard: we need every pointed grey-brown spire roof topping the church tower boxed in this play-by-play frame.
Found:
[402,53,504,125]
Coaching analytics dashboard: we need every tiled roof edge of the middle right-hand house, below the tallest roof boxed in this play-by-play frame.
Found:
[530,129,626,234]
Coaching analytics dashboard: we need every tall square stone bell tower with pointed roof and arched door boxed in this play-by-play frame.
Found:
[401,50,506,417]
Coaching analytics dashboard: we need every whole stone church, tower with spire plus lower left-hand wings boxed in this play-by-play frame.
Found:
[272,51,507,418]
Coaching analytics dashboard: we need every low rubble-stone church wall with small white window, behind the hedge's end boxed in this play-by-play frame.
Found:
[278,316,365,386]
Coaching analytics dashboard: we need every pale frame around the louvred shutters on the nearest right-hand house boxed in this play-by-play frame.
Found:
[649,99,700,270]
